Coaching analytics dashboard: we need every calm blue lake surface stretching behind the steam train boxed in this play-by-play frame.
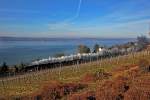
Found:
[0,39,135,65]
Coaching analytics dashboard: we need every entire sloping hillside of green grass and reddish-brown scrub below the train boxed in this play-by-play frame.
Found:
[0,50,150,100]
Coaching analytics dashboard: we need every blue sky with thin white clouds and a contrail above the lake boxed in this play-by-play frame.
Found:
[0,0,150,38]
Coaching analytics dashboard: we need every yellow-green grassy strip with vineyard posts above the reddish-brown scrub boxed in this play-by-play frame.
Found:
[0,51,150,96]
